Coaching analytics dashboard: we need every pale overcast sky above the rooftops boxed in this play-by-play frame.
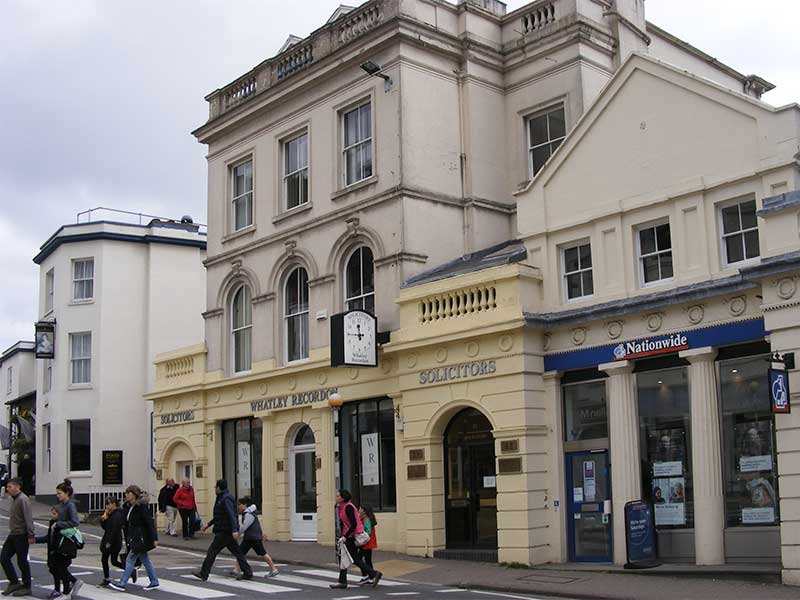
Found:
[0,0,800,350]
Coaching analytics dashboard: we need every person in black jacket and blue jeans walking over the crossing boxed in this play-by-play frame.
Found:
[108,485,158,592]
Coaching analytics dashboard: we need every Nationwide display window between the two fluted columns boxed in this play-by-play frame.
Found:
[636,367,694,528]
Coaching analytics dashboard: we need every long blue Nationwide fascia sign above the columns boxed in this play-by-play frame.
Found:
[544,319,766,371]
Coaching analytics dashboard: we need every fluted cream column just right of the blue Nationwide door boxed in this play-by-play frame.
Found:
[599,360,642,565]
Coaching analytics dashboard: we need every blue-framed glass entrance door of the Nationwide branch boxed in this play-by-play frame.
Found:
[566,450,613,562]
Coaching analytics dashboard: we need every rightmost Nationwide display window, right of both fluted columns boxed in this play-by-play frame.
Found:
[719,355,779,527]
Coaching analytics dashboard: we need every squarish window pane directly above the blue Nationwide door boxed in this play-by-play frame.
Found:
[562,380,608,442]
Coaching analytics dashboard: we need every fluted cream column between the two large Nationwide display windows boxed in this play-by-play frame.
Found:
[680,347,725,565]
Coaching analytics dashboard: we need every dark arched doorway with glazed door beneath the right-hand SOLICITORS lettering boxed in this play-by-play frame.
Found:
[444,408,497,550]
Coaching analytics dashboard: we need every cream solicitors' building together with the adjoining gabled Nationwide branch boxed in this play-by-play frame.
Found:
[146,0,800,580]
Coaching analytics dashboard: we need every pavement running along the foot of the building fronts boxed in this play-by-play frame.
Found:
[0,499,800,600]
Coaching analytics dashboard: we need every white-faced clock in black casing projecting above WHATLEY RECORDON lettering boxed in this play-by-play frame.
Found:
[331,310,378,367]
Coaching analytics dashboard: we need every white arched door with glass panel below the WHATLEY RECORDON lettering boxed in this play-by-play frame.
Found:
[289,425,317,541]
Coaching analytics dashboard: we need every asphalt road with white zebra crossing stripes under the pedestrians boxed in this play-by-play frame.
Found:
[0,516,564,600]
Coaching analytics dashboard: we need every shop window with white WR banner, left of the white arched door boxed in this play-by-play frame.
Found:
[222,418,263,507]
